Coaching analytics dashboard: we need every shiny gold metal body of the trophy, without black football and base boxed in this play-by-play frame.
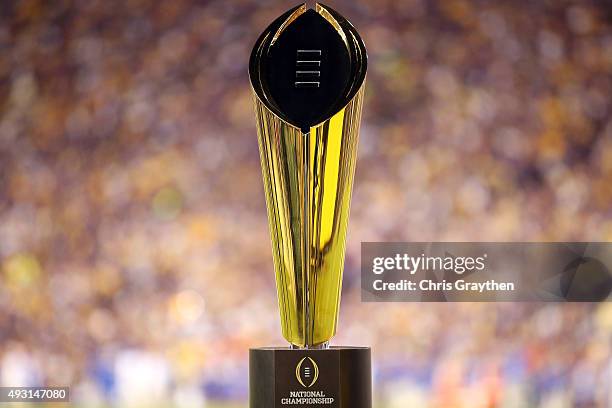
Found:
[251,3,365,347]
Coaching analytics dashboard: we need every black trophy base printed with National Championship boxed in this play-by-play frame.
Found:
[249,347,372,408]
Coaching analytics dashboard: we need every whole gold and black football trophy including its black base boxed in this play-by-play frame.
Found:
[249,3,371,408]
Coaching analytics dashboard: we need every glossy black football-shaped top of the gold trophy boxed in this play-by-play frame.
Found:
[249,4,367,129]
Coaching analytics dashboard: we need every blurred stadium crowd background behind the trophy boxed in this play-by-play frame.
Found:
[0,0,612,408]
